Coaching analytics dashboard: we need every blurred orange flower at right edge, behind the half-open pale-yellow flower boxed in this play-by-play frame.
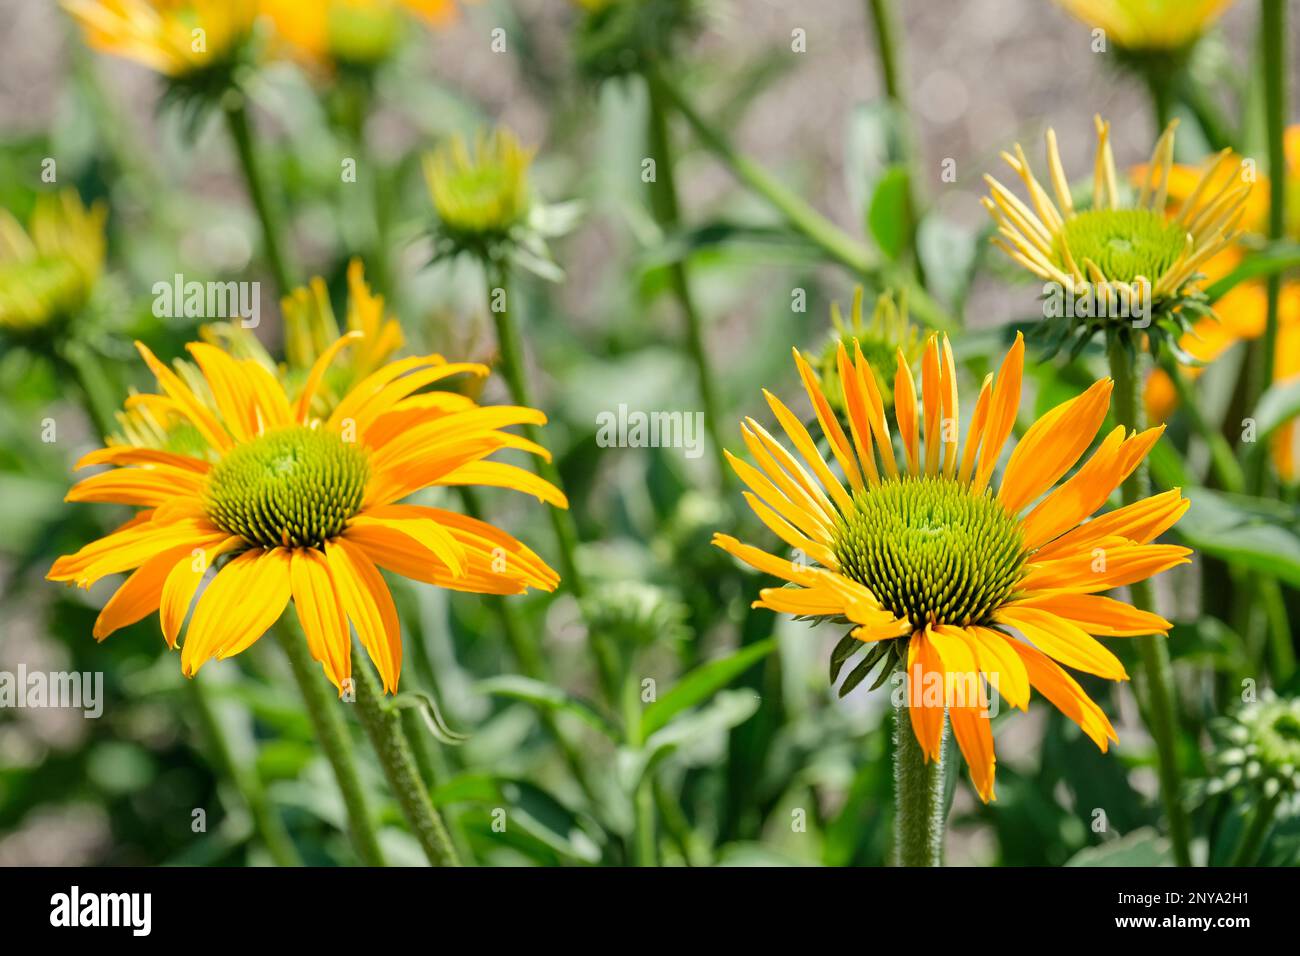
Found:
[1134,125,1300,483]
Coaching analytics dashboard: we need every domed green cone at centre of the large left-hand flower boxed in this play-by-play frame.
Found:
[205,427,369,548]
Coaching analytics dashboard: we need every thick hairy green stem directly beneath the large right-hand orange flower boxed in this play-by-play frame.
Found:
[894,702,948,866]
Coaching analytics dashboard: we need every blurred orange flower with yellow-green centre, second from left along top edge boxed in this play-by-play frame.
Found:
[261,0,456,66]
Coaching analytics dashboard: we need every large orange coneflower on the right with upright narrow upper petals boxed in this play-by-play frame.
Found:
[714,336,1190,800]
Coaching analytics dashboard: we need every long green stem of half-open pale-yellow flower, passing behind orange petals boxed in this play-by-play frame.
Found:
[1106,336,1192,866]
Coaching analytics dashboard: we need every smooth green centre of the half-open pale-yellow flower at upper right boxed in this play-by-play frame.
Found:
[1057,209,1187,282]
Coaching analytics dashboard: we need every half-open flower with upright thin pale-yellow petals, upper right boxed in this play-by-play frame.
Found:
[983,116,1251,345]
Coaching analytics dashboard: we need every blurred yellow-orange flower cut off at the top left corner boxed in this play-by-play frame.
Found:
[62,0,259,79]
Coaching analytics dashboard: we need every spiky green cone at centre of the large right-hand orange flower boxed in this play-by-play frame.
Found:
[835,476,1024,628]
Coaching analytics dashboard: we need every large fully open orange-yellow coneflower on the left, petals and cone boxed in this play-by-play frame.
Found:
[48,332,567,691]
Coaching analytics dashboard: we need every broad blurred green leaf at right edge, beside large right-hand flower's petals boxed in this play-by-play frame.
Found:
[1174,488,1300,587]
